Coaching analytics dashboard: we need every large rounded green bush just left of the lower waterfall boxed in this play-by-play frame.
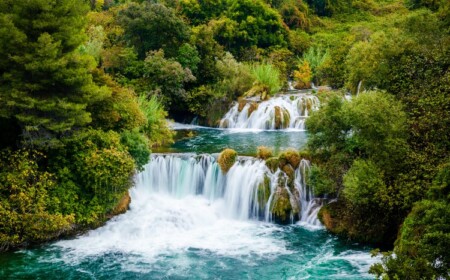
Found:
[49,130,135,226]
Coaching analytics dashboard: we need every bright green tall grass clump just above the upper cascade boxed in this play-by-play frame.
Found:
[251,63,282,94]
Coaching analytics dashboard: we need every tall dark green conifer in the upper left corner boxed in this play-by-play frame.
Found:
[0,0,110,144]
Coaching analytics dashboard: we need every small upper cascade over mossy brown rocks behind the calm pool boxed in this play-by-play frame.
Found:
[220,94,320,130]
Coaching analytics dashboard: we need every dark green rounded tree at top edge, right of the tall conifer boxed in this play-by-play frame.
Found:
[118,1,189,58]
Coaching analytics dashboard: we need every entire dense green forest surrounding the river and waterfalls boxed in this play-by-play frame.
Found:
[0,0,450,279]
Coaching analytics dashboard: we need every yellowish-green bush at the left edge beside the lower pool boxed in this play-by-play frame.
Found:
[0,150,74,251]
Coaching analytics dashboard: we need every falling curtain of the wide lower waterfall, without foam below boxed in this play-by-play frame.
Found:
[136,154,320,225]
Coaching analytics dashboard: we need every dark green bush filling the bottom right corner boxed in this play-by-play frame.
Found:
[370,164,450,279]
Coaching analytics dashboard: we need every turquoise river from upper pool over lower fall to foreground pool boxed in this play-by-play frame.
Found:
[0,94,376,280]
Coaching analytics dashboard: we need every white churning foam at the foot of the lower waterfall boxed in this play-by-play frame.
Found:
[55,188,289,263]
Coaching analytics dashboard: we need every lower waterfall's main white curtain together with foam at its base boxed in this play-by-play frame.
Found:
[57,154,298,263]
